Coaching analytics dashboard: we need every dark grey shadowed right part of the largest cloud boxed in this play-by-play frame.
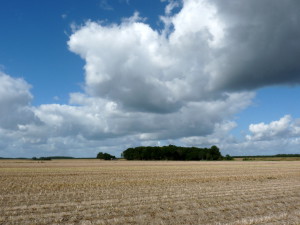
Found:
[213,0,300,90]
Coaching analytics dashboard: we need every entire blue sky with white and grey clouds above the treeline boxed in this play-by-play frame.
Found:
[0,0,300,157]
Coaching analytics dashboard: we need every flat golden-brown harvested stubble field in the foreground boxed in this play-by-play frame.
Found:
[0,159,300,225]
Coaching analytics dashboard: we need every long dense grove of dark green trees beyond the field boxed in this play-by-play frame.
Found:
[122,145,224,160]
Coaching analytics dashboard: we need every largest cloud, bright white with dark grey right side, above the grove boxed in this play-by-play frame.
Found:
[69,0,300,113]
